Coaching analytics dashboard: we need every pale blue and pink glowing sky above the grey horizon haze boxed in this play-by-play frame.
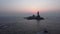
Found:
[0,0,60,16]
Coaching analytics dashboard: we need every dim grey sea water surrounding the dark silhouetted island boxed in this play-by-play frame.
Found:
[0,17,60,34]
